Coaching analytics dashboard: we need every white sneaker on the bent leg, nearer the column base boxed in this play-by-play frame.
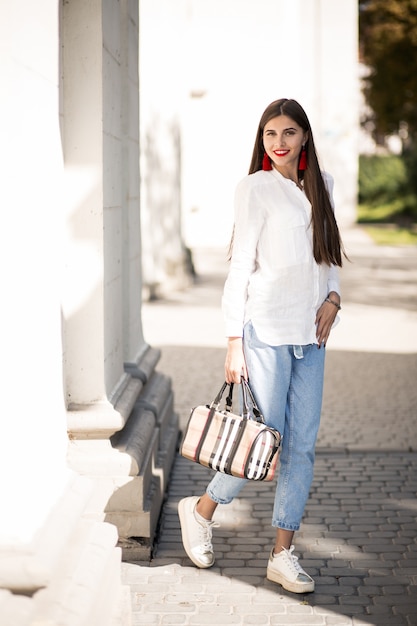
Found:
[178,496,219,568]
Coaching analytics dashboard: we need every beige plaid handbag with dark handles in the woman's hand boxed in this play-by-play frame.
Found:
[180,378,281,481]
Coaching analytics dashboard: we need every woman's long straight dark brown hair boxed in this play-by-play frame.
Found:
[245,98,346,267]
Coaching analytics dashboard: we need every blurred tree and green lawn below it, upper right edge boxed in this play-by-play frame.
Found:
[358,0,417,233]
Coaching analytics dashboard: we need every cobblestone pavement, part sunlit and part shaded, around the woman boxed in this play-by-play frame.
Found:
[123,229,417,626]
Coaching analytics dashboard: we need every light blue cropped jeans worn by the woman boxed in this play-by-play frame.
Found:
[207,322,325,530]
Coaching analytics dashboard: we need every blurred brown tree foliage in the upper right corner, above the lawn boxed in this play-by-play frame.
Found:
[359,0,417,143]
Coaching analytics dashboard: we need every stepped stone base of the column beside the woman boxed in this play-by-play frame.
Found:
[68,348,179,558]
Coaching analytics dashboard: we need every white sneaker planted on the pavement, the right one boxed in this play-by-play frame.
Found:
[266,546,314,593]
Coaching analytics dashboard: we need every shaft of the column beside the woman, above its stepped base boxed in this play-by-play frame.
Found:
[63,0,142,428]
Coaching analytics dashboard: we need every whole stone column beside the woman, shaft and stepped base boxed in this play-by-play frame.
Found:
[62,0,177,545]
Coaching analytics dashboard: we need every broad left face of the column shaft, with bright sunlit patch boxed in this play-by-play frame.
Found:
[62,0,106,406]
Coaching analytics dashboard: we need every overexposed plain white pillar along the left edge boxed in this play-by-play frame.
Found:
[0,0,69,549]
